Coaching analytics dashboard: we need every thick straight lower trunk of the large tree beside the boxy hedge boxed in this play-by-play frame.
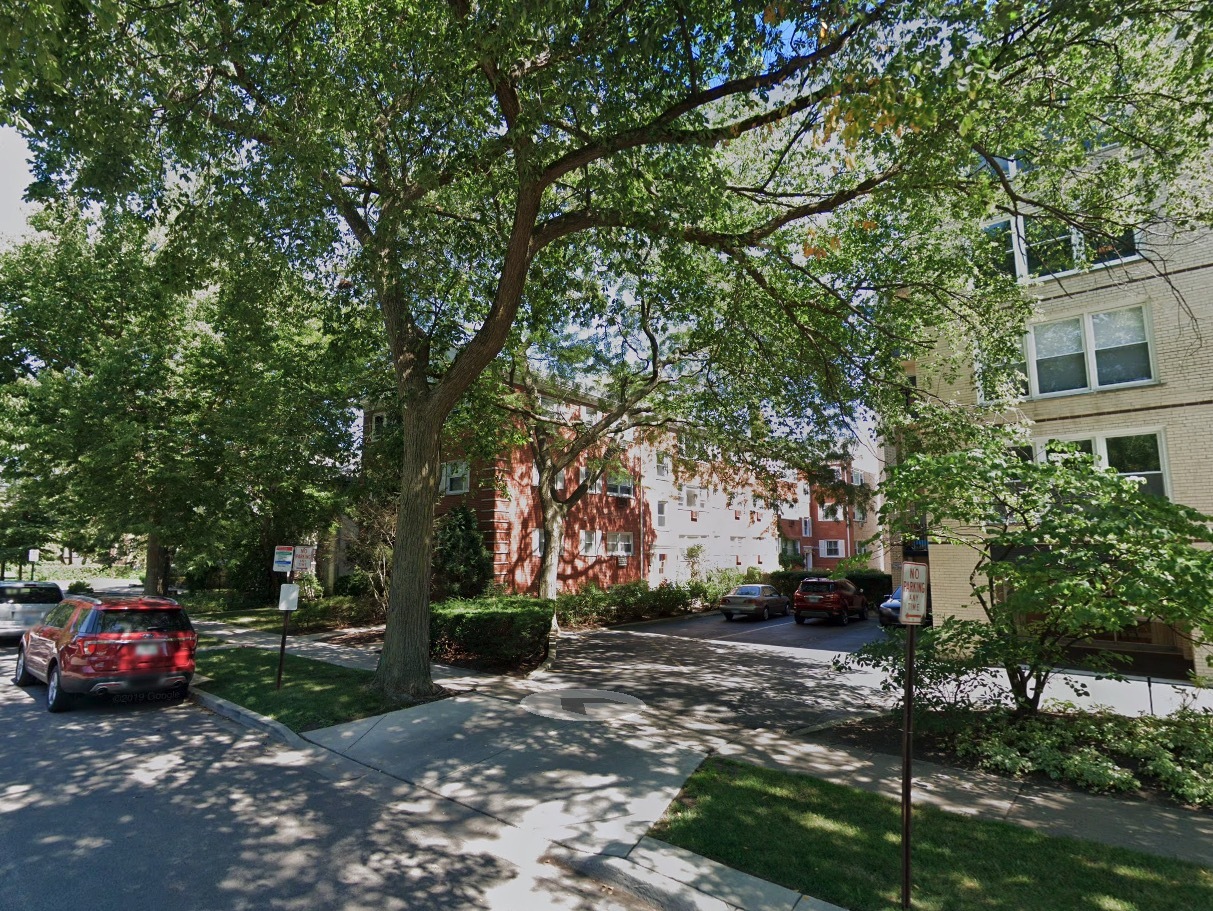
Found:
[375,408,442,699]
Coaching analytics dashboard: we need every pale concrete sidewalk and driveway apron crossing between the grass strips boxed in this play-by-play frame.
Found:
[195,621,1213,911]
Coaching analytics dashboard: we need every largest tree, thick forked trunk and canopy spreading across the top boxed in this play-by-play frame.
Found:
[7,0,1209,694]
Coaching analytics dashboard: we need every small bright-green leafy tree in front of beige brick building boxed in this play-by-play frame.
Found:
[882,427,1213,712]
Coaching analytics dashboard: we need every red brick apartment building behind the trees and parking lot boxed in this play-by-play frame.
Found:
[354,402,876,592]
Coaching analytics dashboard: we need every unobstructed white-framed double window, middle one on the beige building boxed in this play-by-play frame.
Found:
[1026,307,1154,395]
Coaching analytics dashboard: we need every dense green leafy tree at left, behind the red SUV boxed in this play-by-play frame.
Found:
[0,203,357,592]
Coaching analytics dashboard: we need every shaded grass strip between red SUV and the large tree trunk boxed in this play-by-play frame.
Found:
[189,648,436,731]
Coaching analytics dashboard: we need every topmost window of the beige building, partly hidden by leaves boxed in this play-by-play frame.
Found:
[985,215,1140,280]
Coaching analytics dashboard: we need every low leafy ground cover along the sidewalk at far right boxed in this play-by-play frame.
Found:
[956,708,1213,807]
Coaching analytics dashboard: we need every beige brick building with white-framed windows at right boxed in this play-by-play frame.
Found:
[894,217,1213,678]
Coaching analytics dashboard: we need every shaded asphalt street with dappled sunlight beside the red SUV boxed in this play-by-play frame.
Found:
[0,643,645,911]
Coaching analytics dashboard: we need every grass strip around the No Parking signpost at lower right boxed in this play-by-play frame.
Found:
[650,759,1213,911]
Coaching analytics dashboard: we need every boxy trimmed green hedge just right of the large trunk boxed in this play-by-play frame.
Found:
[429,594,552,668]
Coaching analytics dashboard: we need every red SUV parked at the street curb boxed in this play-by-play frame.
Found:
[13,594,198,712]
